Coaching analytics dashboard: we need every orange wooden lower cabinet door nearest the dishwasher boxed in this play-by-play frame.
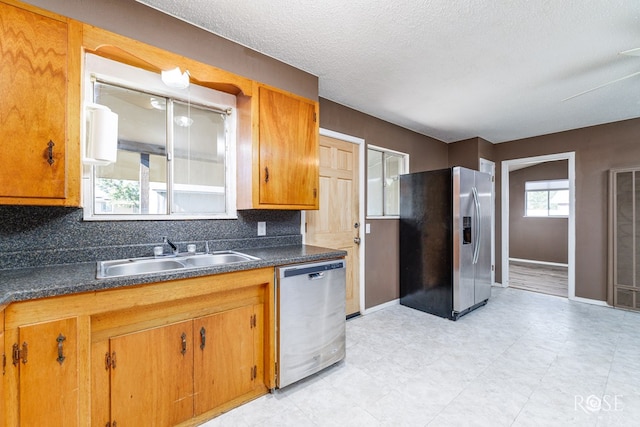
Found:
[194,304,262,415]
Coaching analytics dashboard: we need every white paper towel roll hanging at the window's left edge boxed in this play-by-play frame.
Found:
[82,104,118,165]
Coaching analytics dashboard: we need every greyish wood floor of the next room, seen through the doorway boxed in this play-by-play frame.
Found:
[509,261,569,298]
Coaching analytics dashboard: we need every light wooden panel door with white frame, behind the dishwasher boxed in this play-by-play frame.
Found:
[302,129,365,316]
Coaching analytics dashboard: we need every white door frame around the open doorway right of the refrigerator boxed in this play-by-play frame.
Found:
[501,152,575,299]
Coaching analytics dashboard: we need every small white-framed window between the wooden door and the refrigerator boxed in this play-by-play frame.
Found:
[367,145,409,217]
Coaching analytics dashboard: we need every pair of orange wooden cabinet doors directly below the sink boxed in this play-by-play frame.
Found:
[105,304,263,426]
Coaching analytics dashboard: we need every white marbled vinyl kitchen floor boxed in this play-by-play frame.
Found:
[202,287,640,427]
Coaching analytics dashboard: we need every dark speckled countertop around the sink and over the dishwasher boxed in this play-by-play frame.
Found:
[0,245,347,305]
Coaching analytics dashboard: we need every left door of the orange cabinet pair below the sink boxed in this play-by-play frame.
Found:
[110,320,194,427]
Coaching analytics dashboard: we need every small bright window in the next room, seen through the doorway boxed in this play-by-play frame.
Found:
[525,179,569,217]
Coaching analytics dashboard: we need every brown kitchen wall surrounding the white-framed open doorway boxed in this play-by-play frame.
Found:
[494,119,640,301]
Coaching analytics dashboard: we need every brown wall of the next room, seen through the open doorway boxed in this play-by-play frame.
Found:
[509,160,569,264]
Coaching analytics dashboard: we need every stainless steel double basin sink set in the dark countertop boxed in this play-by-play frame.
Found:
[96,251,260,279]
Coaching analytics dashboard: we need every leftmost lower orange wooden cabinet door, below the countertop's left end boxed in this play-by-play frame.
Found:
[17,318,78,427]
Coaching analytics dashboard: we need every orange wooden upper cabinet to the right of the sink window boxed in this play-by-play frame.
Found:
[238,85,319,209]
